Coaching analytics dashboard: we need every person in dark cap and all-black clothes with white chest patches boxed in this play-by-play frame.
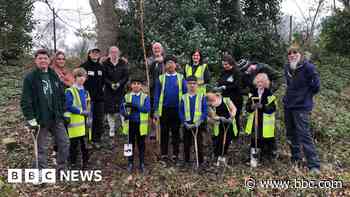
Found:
[80,48,105,148]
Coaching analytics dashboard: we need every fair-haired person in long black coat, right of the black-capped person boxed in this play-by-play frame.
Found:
[103,46,129,137]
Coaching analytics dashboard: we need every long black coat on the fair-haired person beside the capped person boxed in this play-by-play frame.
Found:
[103,58,129,113]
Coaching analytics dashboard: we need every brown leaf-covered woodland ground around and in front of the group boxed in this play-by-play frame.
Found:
[0,62,350,197]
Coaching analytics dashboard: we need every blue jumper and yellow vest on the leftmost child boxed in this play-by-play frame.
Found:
[64,87,90,138]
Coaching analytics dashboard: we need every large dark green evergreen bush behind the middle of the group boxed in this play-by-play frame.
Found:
[118,0,285,70]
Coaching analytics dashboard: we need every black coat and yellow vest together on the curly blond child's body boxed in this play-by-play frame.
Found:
[245,89,277,138]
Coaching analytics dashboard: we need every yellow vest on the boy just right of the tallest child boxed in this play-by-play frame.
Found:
[182,93,204,123]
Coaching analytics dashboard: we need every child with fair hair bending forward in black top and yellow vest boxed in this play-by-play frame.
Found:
[207,91,238,162]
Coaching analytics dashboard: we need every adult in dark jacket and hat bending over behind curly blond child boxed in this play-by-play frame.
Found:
[239,60,282,94]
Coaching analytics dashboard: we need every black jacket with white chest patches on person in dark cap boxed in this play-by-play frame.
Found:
[80,57,105,102]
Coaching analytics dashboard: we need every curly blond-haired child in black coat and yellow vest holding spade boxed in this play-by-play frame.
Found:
[245,73,276,165]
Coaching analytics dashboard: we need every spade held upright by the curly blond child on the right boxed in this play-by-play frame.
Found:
[250,97,260,168]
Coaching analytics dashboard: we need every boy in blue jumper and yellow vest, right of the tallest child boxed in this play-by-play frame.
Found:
[179,76,208,165]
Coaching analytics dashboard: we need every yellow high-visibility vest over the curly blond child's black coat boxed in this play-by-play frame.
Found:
[245,95,277,138]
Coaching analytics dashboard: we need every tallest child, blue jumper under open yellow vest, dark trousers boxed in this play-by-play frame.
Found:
[154,56,187,163]
